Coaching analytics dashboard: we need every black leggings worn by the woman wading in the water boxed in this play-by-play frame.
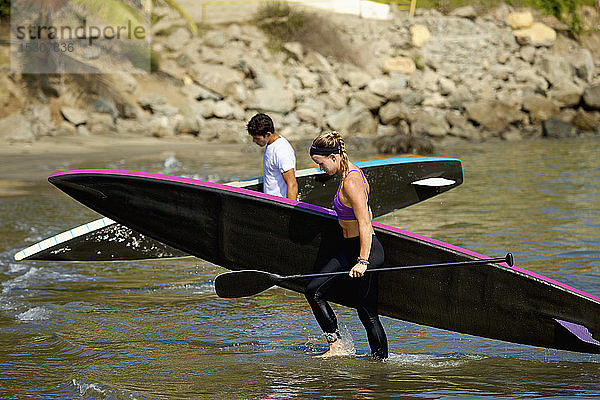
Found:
[305,235,388,359]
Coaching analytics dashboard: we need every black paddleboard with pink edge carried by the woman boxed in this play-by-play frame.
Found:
[49,170,600,353]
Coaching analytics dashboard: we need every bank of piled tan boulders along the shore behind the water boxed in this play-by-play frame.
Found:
[0,5,600,153]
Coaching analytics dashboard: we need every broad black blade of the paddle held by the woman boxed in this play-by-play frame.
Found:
[215,270,280,299]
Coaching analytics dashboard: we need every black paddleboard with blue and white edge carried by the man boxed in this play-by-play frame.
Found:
[15,157,463,261]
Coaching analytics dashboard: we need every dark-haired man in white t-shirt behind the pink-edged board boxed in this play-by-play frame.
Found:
[248,114,298,200]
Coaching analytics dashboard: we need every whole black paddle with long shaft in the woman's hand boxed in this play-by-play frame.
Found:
[215,253,514,298]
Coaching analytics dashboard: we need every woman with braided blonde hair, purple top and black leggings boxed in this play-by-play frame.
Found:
[305,132,388,359]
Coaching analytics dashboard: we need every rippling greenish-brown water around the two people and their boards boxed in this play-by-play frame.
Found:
[0,139,600,400]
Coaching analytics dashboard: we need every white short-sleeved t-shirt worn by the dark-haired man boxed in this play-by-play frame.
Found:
[263,137,296,197]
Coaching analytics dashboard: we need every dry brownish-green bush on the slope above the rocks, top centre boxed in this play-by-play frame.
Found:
[254,1,362,65]
